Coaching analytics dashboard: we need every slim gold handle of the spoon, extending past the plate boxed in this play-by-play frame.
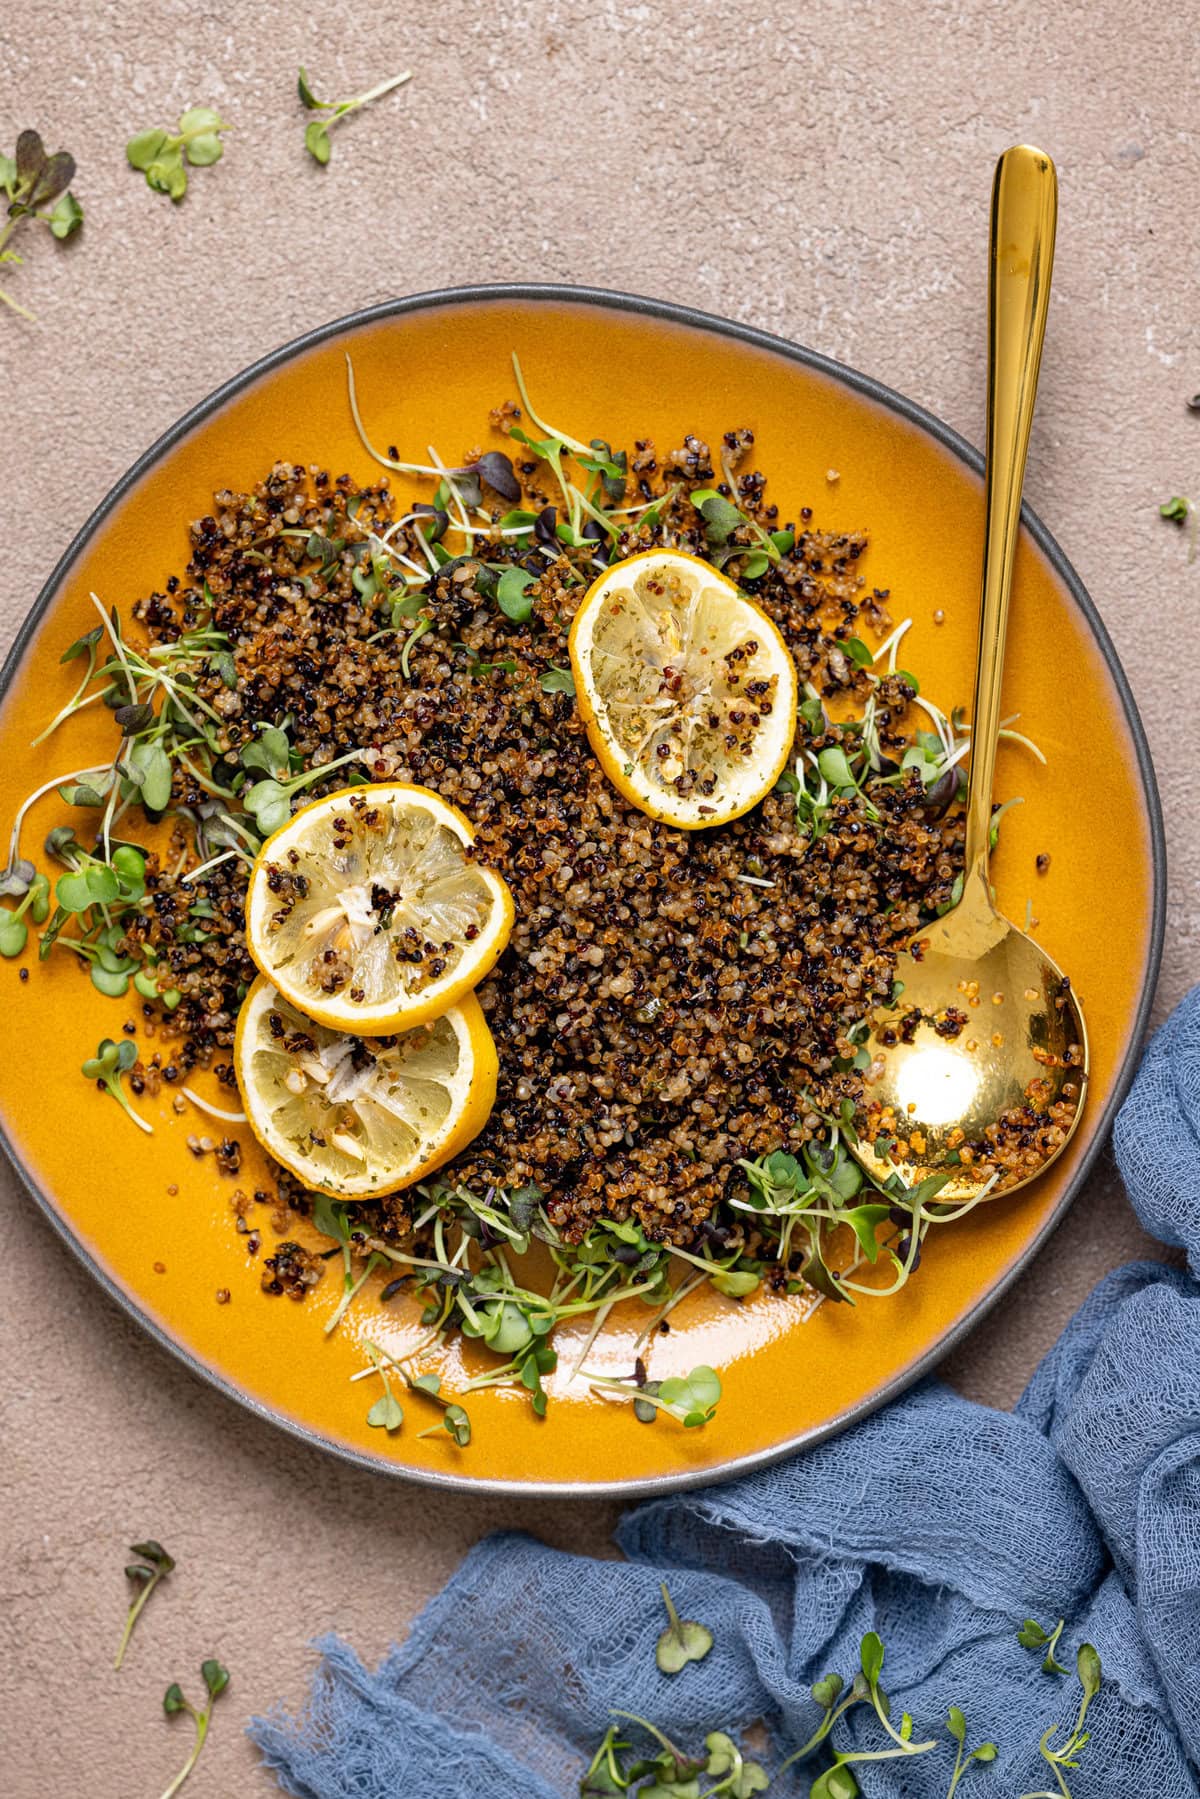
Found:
[966,144,1058,877]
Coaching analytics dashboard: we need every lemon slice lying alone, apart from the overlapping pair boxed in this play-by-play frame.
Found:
[570,550,797,831]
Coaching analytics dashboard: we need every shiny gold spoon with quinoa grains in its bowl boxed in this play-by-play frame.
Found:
[855,144,1087,1200]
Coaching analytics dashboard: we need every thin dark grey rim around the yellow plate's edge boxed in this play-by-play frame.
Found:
[0,282,1166,1499]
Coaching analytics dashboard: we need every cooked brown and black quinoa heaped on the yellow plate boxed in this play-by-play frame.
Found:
[131,435,963,1252]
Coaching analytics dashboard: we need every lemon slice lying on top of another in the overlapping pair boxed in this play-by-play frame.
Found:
[246,783,513,1036]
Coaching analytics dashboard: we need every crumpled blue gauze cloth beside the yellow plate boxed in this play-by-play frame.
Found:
[250,989,1200,1799]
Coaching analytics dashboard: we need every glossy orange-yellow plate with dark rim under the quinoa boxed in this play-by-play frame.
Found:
[0,288,1164,1493]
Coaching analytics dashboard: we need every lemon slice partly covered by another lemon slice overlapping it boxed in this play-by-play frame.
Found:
[234,977,497,1200]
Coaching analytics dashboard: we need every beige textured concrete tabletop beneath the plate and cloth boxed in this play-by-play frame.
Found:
[0,0,1200,1799]
